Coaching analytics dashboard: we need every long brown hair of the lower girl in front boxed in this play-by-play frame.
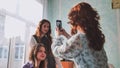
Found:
[29,43,46,68]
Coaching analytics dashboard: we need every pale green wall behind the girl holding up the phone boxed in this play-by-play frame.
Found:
[47,0,120,68]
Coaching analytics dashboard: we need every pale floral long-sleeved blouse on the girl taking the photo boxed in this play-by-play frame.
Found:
[52,32,108,68]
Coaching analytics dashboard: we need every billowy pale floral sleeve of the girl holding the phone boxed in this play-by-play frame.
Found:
[52,35,82,59]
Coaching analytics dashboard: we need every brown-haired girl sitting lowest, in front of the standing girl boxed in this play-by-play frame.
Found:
[23,43,47,68]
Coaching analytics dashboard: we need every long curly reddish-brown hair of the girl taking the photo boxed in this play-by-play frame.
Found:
[68,2,105,51]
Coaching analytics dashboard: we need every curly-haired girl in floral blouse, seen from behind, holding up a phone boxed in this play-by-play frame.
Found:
[52,2,108,68]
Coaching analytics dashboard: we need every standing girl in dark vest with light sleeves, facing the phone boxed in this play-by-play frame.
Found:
[30,19,61,68]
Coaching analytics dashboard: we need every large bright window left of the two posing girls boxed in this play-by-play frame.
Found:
[0,0,44,68]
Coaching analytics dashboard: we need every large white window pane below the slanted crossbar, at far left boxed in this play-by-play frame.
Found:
[5,16,25,40]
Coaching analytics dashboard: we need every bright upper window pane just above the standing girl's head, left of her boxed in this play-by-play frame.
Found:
[20,0,43,24]
